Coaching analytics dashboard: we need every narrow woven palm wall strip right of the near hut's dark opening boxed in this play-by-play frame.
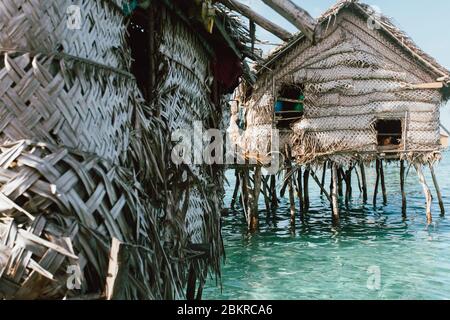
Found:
[154,6,225,288]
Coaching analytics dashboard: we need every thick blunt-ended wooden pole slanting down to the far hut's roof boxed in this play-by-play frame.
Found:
[263,0,317,42]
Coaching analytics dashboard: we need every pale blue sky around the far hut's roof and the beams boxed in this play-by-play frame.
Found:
[239,0,450,128]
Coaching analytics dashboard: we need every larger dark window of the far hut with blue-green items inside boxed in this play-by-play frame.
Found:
[275,85,305,129]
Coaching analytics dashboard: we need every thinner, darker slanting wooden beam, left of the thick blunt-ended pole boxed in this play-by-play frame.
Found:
[219,0,293,41]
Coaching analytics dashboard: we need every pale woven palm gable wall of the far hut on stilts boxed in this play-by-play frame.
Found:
[241,10,442,164]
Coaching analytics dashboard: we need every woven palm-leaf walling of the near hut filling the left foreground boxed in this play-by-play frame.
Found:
[0,0,221,299]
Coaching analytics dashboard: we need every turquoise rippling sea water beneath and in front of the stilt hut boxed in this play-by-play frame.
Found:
[204,153,450,299]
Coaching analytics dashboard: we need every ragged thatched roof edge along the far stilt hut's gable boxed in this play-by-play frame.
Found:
[259,0,450,82]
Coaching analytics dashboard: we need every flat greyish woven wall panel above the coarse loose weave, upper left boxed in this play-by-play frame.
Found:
[0,0,131,163]
